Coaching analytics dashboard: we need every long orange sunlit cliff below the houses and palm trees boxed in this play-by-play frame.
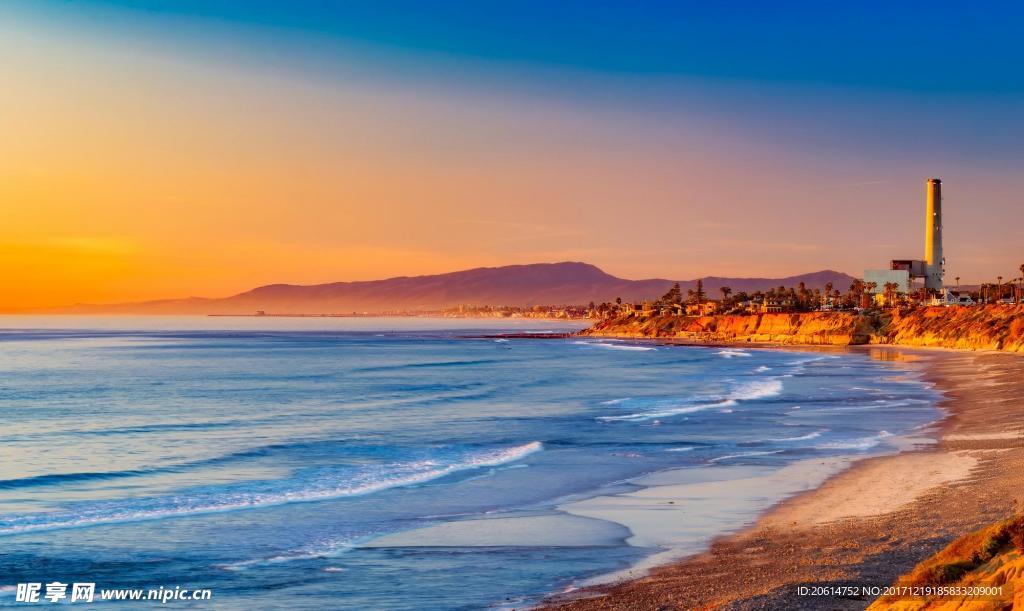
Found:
[583,305,1024,352]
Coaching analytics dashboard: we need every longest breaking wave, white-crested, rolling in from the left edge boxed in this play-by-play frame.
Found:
[0,441,544,535]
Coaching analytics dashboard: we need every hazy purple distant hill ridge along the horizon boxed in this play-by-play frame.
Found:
[61,262,854,314]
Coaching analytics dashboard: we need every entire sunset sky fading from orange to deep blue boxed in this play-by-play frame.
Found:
[0,0,1024,311]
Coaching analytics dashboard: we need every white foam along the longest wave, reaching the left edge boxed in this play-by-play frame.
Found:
[0,441,544,535]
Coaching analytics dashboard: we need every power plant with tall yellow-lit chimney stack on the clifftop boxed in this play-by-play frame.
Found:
[864,178,946,294]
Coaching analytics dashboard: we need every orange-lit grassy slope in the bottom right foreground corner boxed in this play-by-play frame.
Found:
[868,516,1024,611]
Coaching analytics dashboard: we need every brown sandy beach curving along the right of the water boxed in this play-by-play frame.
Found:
[546,347,1024,611]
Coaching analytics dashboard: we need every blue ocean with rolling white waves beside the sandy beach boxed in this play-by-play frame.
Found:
[0,316,941,610]
